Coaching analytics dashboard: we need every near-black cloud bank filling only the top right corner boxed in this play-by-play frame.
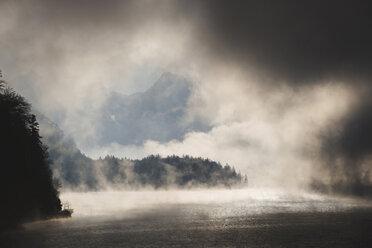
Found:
[195,0,372,84]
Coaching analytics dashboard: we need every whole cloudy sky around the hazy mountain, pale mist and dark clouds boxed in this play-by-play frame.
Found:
[0,0,372,192]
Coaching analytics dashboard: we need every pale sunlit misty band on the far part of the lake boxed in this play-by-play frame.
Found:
[61,189,370,217]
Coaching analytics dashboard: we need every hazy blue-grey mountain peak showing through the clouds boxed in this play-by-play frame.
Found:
[100,73,210,145]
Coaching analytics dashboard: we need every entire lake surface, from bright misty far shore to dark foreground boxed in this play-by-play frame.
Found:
[0,189,372,248]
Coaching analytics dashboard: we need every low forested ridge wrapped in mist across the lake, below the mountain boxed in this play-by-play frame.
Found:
[96,155,244,189]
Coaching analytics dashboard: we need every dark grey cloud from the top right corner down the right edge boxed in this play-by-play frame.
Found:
[185,0,372,195]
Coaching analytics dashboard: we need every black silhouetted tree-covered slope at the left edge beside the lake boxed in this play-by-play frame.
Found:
[0,81,61,230]
